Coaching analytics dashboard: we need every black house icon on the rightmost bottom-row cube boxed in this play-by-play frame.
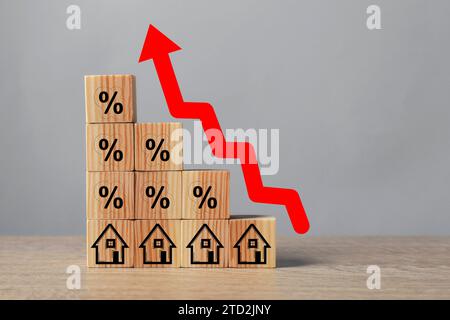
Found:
[233,223,270,264]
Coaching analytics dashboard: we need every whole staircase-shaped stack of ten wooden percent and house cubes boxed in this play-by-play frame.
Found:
[85,75,276,268]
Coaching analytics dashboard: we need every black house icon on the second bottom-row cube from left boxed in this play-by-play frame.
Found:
[139,223,176,264]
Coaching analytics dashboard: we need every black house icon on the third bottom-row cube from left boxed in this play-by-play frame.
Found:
[186,224,223,264]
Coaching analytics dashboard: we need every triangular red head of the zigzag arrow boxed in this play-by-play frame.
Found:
[139,25,181,62]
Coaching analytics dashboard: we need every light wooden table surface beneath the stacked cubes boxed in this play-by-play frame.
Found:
[0,236,450,299]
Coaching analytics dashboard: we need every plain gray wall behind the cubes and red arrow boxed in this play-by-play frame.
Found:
[0,0,450,235]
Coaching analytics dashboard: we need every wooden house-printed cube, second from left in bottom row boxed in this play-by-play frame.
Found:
[134,220,181,268]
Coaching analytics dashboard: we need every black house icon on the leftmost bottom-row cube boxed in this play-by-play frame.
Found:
[91,224,128,264]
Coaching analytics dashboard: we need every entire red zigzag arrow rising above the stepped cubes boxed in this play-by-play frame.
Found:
[139,25,309,233]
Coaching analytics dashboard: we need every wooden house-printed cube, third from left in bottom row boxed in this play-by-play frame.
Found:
[181,220,229,268]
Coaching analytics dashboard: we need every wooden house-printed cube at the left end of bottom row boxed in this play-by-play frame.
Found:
[86,220,134,268]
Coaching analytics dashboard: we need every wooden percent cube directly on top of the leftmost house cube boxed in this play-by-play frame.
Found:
[86,172,134,219]
